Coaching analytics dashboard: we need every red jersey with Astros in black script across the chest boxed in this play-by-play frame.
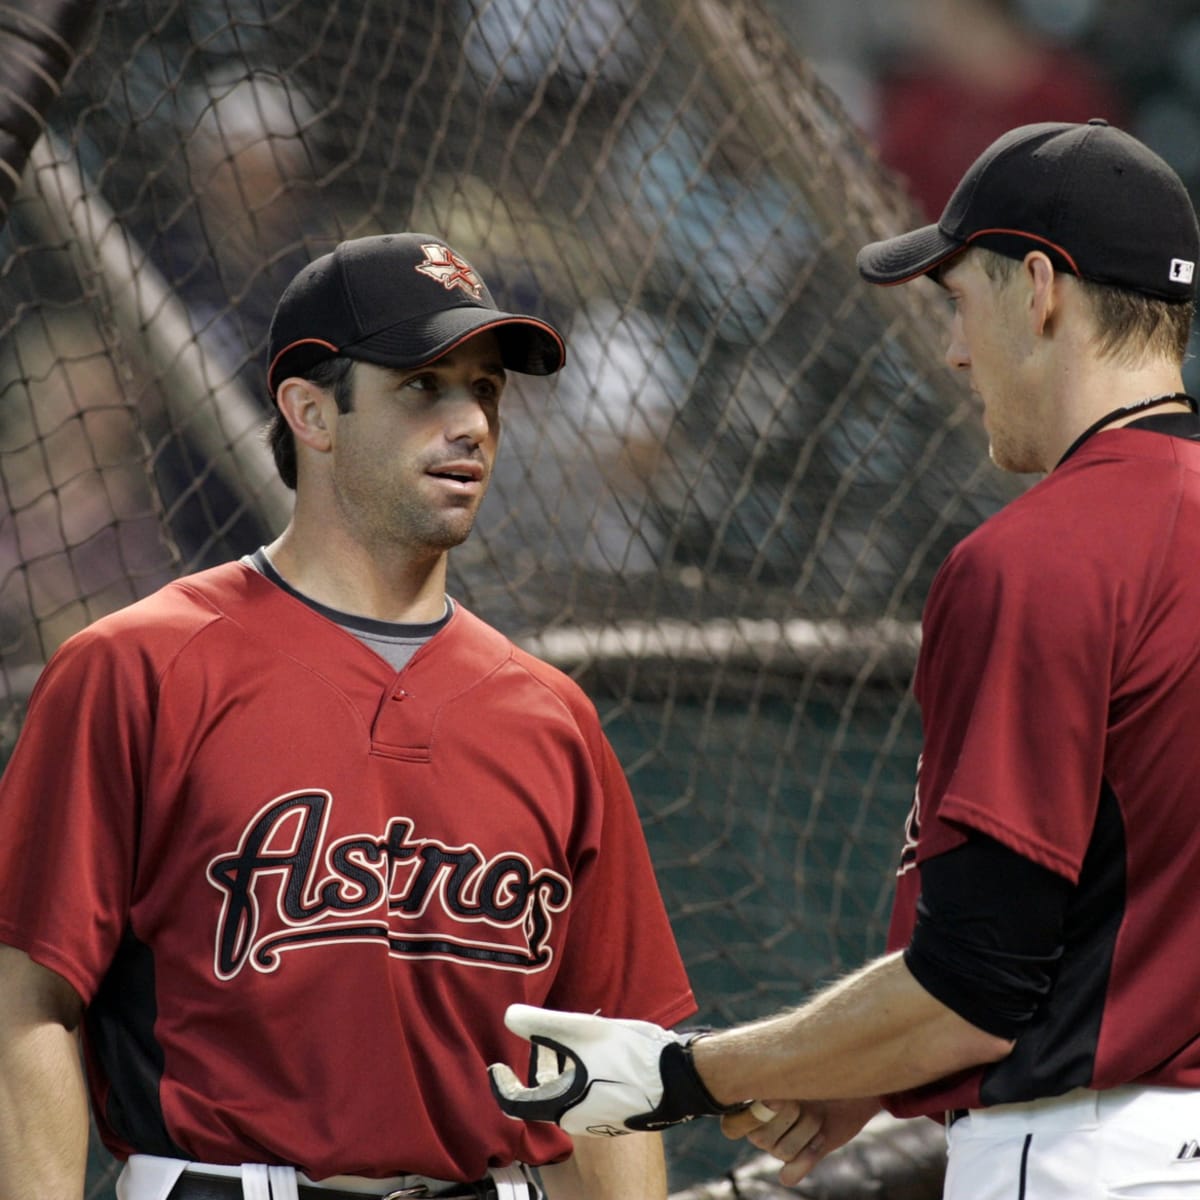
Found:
[0,564,696,1180]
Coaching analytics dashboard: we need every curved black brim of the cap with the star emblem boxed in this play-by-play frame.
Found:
[342,306,566,374]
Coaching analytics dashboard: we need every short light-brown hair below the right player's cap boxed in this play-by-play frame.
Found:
[974,246,1195,364]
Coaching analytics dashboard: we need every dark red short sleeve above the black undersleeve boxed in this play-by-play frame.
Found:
[916,526,1115,882]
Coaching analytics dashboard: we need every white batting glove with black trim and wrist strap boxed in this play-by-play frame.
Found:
[488,1004,744,1138]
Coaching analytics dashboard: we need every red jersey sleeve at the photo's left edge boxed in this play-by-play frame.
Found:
[0,634,149,1003]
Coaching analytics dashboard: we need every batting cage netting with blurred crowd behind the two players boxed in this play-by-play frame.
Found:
[0,0,1021,1200]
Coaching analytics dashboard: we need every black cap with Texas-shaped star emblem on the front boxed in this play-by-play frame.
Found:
[266,233,566,398]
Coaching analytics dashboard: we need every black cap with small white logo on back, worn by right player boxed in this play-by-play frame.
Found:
[858,118,1200,300]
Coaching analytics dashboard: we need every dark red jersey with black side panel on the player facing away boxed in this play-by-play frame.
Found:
[889,428,1200,1116]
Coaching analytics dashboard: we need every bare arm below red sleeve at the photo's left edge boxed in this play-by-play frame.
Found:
[0,947,88,1200]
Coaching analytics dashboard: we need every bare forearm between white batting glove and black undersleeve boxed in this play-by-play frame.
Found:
[692,954,1012,1103]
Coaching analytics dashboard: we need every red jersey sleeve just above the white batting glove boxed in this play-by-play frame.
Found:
[546,726,696,1026]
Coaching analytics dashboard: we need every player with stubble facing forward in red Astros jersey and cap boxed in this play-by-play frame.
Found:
[0,234,695,1200]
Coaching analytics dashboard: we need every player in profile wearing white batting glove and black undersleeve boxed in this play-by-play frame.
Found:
[493,120,1200,1200]
